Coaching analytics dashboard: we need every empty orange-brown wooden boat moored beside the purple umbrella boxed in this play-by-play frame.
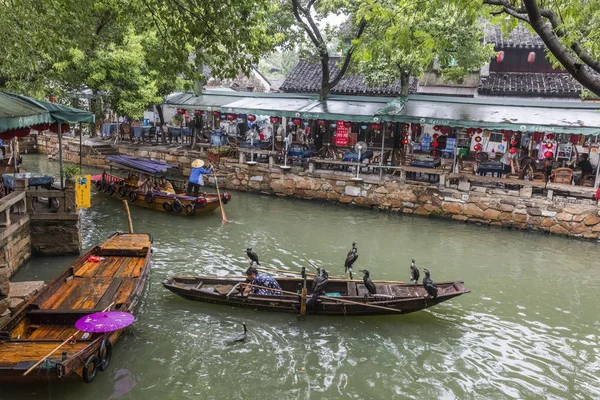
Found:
[0,233,152,383]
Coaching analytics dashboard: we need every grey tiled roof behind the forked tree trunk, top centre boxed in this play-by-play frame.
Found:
[279,58,417,96]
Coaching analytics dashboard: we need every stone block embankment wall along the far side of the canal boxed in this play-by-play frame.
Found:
[40,134,600,239]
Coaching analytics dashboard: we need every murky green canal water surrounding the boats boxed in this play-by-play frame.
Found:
[0,156,600,400]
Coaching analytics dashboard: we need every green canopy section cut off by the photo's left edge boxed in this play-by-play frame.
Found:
[0,92,51,133]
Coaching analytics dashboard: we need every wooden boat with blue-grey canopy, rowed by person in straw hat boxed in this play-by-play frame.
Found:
[92,156,231,217]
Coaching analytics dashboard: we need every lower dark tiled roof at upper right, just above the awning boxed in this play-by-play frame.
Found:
[478,72,581,98]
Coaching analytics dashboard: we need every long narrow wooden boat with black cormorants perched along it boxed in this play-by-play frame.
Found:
[163,276,470,316]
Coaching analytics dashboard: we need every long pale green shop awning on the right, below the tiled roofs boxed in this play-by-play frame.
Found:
[378,95,600,135]
